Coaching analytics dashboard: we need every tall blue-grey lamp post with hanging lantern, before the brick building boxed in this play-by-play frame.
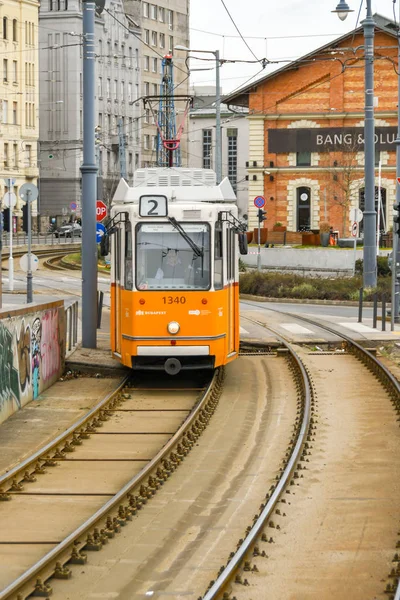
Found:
[332,0,377,288]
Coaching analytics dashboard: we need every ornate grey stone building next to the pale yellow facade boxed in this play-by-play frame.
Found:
[40,0,140,220]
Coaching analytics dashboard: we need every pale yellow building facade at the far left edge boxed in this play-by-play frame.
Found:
[0,0,39,231]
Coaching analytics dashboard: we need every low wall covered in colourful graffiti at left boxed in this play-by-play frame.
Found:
[0,301,65,423]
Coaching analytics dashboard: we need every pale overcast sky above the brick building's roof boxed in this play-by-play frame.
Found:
[180,0,400,93]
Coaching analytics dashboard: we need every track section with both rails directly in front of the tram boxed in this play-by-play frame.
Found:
[0,369,223,600]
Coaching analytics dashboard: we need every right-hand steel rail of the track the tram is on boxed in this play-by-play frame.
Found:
[0,369,223,600]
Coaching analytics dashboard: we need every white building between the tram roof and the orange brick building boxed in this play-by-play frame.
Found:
[188,85,249,217]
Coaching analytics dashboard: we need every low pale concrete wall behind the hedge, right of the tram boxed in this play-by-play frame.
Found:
[241,247,389,275]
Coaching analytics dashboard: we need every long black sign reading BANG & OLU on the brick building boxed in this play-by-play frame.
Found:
[268,127,397,154]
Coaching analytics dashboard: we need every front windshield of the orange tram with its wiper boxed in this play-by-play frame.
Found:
[136,223,210,290]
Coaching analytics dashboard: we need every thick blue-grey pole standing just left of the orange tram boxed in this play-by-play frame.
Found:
[81,0,97,348]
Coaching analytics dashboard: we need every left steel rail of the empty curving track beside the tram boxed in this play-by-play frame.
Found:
[203,328,311,600]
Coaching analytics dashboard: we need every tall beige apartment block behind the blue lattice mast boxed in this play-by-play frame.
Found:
[124,0,190,167]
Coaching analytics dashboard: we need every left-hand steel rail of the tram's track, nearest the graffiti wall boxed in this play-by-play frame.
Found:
[0,374,131,493]
